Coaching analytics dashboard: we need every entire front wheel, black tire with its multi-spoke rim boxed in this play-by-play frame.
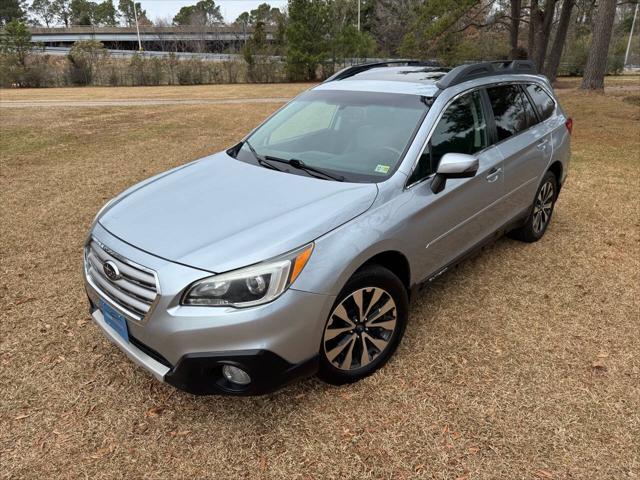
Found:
[318,265,409,385]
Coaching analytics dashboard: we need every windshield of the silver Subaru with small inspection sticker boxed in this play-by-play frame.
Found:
[236,91,428,182]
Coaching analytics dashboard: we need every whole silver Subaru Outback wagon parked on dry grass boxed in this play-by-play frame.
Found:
[84,61,572,395]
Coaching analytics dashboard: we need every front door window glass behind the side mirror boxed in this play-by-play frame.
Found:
[409,90,489,184]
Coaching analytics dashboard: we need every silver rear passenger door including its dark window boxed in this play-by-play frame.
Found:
[486,84,552,216]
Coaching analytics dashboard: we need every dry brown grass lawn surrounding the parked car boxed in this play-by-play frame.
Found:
[0,77,640,479]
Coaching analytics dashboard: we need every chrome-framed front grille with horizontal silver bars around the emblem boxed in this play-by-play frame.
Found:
[85,239,158,320]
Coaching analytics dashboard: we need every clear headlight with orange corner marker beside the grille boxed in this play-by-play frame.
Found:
[182,243,313,307]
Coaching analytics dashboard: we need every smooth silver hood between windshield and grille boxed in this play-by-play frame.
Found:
[99,153,378,273]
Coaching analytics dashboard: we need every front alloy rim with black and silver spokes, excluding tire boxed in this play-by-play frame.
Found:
[323,287,398,371]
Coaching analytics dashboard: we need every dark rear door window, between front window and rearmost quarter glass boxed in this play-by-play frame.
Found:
[487,85,535,141]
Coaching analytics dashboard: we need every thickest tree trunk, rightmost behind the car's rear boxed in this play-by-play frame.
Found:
[580,0,616,90]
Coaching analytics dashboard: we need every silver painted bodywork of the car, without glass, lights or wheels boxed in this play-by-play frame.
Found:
[86,66,570,382]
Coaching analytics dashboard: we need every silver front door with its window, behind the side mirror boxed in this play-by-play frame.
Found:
[409,90,504,279]
